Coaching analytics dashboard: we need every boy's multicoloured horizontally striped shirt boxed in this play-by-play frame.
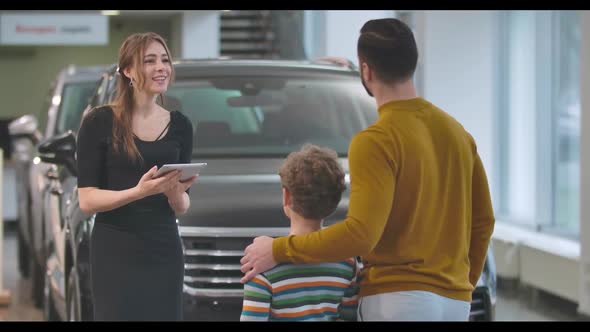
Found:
[240,258,360,321]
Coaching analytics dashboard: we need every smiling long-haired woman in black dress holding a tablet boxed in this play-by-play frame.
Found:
[77,33,196,321]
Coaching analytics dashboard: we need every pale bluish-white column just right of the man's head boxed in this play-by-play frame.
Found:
[415,11,497,200]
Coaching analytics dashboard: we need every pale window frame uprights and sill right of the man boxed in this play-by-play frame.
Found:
[494,11,580,240]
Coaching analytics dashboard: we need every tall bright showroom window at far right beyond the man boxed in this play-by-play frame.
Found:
[495,11,580,238]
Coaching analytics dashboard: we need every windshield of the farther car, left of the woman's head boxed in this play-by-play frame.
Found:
[56,81,96,133]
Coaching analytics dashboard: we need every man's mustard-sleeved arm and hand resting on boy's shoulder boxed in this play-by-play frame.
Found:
[241,129,397,282]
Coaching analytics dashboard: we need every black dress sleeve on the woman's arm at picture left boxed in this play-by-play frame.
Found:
[76,109,106,188]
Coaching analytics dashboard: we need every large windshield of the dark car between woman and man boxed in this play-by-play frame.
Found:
[164,76,377,157]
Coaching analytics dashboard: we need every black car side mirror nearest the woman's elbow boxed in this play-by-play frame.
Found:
[37,130,78,176]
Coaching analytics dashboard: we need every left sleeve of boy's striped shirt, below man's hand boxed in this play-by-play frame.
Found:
[240,274,272,321]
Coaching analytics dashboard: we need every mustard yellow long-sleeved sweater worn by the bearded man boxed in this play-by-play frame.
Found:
[273,98,494,301]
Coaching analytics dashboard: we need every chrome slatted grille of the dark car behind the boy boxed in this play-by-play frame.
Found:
[179,227,289,297]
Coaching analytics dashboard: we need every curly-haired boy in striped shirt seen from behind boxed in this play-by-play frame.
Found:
[240,144,360,321]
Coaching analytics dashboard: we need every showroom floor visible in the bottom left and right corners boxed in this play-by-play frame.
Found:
[0,225,582,321]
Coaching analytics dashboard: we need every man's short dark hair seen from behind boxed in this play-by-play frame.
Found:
[357,18,418,83]
